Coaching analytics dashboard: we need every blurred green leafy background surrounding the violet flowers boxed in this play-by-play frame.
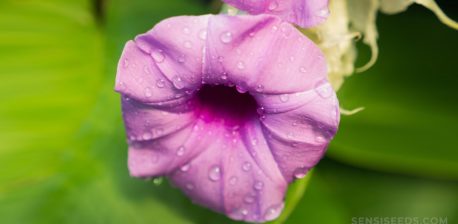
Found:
[0,0,458,224]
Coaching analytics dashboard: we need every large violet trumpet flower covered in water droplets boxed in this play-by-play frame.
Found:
[116,15,340,222]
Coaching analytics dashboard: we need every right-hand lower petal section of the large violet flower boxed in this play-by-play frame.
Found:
[257,80,340,182]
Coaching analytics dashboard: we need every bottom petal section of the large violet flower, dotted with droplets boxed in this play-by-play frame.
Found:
[171,121,287,222]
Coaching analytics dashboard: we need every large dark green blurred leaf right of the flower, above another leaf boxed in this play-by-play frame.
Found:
[328,6,458,179]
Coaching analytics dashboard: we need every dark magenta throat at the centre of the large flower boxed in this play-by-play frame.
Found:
[197,85,258,123]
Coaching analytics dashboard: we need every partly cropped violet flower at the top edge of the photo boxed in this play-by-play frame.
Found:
[223,0,329,27]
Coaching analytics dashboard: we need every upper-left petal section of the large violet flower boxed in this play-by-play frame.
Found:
[135,15,210,90]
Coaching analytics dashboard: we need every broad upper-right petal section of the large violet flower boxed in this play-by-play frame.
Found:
[204,15,326,94]
